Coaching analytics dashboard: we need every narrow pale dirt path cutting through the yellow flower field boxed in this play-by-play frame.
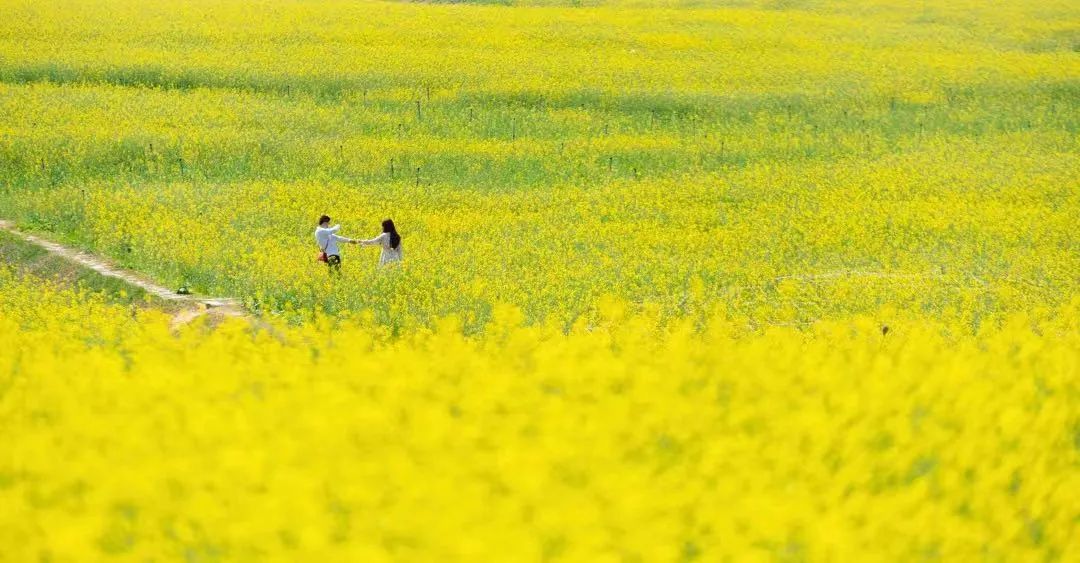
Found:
[0,219,247,329]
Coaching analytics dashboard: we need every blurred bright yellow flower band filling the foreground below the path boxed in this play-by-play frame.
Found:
[0,273,1080,562]
